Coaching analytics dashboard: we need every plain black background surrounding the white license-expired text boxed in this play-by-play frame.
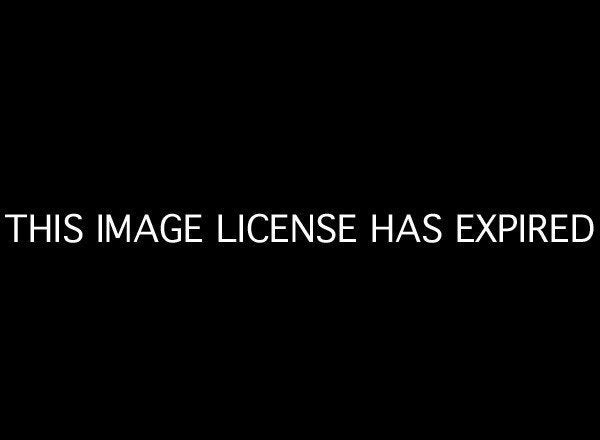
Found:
[1,5,598,433]
